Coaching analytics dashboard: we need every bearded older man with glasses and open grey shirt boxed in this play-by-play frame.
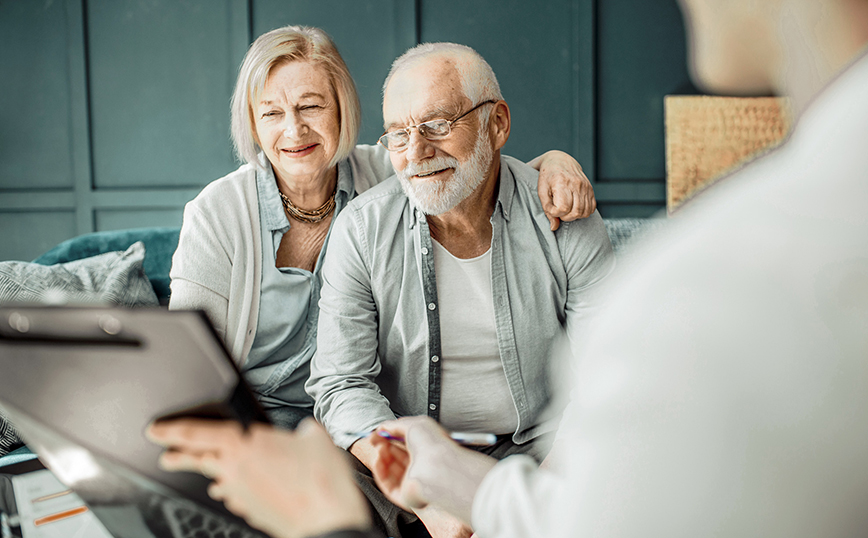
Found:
[306,43,614,535]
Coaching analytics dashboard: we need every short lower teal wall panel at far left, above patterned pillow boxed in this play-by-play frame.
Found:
[0,211,75,261]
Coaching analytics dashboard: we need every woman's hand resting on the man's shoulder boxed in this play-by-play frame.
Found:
[527,150,597,231]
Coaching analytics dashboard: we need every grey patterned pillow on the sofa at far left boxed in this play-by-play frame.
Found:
[0,242,160,456]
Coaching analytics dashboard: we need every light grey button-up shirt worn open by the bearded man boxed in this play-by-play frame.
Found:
[305,157,614,448]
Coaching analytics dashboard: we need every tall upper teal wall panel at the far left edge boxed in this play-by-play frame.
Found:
[0,1,73,189]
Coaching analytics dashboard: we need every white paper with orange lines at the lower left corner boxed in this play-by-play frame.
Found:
[12,470,112,538]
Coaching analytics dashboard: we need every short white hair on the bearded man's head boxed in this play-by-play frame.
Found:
[383,43,503,112]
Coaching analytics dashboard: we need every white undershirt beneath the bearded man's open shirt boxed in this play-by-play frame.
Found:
[432,241,518,434]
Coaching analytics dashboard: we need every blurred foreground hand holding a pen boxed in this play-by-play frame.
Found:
[370,417,497,525]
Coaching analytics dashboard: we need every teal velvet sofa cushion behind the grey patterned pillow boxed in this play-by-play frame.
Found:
[33,228,181,304]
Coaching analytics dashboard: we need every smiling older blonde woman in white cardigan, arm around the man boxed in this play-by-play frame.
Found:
[169,26,594,428]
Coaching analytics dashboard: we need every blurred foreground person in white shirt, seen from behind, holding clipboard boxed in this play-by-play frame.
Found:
[147,0,868,538]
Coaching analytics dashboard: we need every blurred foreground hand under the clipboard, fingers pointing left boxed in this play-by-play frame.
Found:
[147,419,371,538]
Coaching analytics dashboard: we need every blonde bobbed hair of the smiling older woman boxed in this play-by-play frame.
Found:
[231,26,362,166]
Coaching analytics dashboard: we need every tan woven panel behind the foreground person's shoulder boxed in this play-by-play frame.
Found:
[664,95,790,213]
